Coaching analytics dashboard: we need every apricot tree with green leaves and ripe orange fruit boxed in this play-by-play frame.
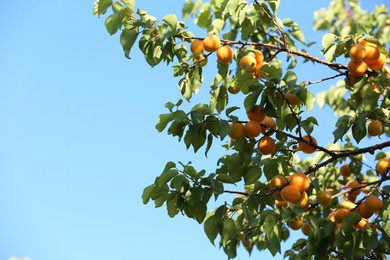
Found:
[93,0,390,259]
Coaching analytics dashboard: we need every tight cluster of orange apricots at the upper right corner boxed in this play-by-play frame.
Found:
[348,40,386,77]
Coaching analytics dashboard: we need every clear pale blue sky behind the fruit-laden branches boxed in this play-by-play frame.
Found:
[0,0,385,260]
